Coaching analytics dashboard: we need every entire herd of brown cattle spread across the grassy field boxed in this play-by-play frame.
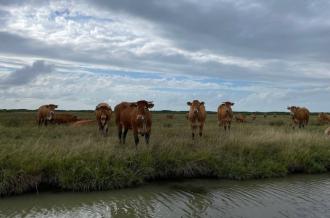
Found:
[37,100,330,145]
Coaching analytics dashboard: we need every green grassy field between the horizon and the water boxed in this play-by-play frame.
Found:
[0,111,330,196]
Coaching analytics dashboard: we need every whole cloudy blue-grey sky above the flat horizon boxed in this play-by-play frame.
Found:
[0,0,330,112]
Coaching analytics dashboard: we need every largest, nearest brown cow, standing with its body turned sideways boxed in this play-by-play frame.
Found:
[115,100,154,147]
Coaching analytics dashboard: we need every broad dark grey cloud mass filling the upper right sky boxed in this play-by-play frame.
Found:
[89,0,330,59]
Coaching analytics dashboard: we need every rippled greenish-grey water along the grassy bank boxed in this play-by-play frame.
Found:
[0,174,330,218]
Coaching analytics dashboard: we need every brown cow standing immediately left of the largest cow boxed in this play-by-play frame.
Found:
[95,103,112,136]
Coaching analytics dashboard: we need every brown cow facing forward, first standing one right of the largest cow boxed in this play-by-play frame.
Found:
[187,100,206,139]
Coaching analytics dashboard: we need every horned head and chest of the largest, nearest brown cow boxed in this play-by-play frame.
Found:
[130,100,154,135]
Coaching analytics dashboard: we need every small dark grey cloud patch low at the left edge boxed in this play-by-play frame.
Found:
[0,61,54,86]
